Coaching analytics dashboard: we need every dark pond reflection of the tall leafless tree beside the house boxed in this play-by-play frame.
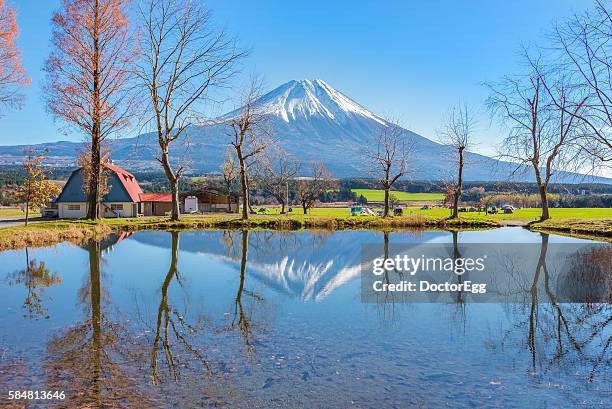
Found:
[151,231,210,384]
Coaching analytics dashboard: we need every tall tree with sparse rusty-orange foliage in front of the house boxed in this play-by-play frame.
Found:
[45,0,136,219]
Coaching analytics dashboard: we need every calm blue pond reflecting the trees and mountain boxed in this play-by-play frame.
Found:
[0,228,612,408]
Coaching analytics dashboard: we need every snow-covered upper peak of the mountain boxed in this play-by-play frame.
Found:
[258,79,385,124]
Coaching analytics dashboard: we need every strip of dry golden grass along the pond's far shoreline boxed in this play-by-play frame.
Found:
[0,214,612,250]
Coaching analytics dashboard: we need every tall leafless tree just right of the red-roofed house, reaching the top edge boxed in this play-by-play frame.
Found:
[138,0,245,220]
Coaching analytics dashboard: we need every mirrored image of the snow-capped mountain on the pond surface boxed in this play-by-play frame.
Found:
[131,231,444,301]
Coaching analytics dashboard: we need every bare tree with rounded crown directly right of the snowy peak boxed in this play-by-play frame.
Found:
[364,121,412,217]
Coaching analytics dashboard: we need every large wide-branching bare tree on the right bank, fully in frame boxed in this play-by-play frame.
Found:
[487,54,582,221]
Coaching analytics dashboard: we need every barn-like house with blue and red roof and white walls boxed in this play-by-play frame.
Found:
[56,163,172,219]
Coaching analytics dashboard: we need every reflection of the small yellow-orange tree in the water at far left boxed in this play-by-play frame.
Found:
[8,247,62,318]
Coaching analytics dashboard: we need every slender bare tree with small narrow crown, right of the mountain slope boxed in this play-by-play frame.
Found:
[440,104,476,219]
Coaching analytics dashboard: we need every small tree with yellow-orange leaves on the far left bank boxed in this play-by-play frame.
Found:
[18,149,60,226]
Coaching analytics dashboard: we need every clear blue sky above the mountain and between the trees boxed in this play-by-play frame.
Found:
[0,0,592,154]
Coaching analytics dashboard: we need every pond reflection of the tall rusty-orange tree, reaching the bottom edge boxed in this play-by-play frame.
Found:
[45,241,152,408]
